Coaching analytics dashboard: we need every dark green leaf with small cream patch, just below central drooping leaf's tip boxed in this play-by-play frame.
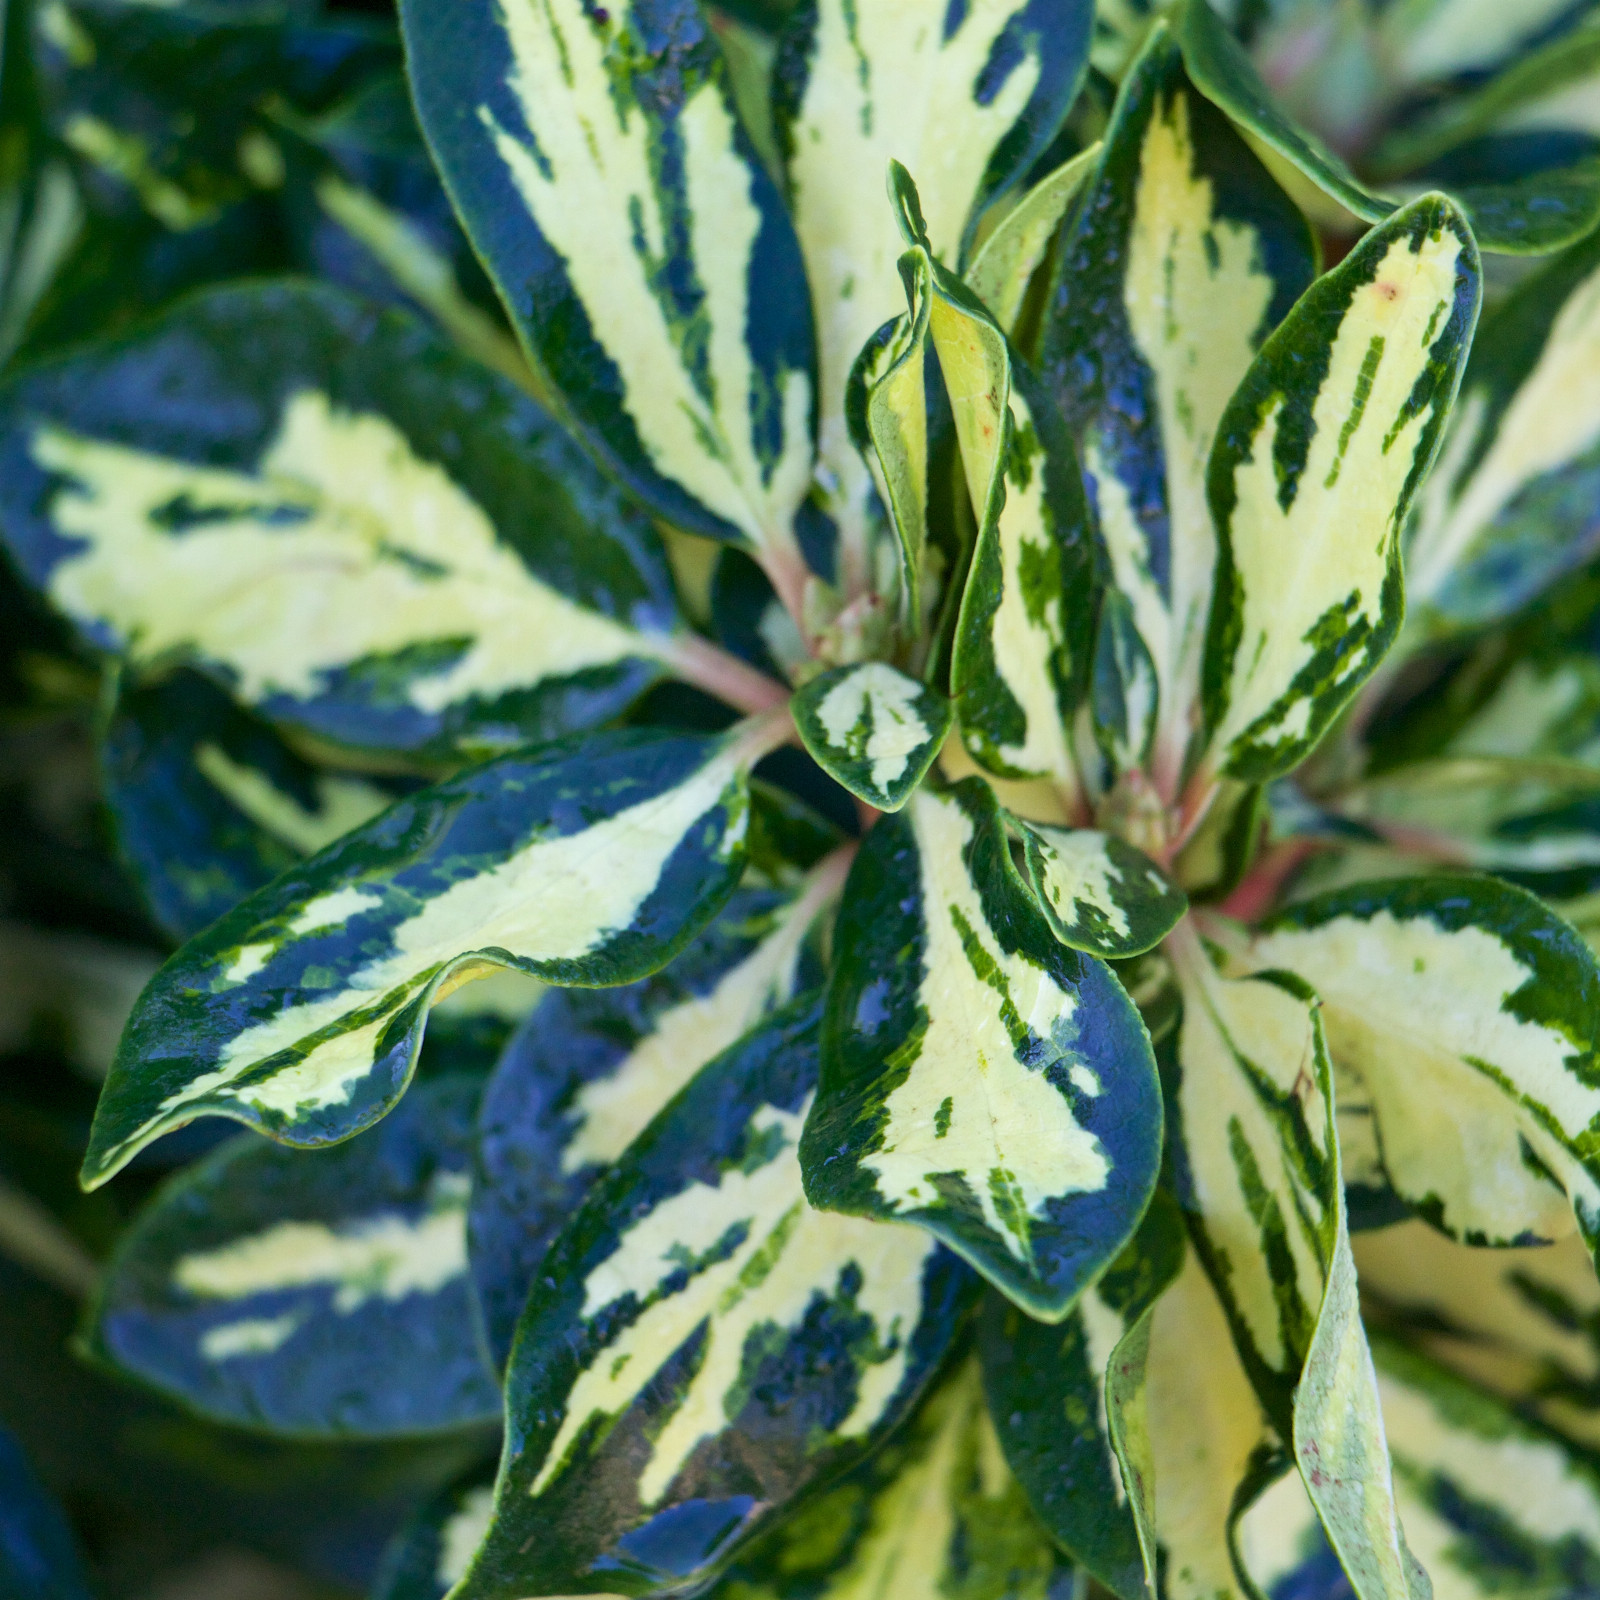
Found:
[978,1189,1184,1600]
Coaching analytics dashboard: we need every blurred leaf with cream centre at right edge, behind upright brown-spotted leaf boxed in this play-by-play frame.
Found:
[1405,225,1600,632]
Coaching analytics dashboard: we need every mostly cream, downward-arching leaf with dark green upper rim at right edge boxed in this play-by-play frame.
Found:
[1251,877,1600,1250]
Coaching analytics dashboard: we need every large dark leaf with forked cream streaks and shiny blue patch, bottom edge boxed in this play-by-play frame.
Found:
[454,1000,973,1600]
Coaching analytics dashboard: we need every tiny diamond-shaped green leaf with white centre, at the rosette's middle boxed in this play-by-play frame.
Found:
[789,661,955,811]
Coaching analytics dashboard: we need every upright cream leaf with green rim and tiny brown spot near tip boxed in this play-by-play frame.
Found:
[1203,195,1480,782]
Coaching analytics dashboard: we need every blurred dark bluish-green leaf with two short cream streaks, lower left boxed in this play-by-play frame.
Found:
[88,1077,499,1438]
